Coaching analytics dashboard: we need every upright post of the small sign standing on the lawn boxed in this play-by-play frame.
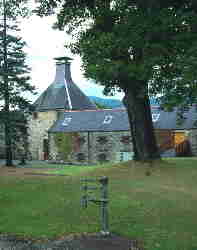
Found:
[99,176,109,235]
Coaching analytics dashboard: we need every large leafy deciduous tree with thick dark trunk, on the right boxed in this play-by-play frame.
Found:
[36,0,197,160]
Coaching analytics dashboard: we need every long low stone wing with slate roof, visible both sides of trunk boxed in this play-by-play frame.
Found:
[49,106,197,163]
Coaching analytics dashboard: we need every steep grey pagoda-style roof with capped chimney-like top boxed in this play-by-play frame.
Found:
[33,57,96,111]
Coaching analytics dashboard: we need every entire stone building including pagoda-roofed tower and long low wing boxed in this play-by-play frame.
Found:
[29,57,197,163]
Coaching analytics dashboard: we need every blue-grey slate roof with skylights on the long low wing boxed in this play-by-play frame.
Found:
[49,107,197,133]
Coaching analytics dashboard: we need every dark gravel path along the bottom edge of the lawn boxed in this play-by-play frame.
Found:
[0,234,142,250]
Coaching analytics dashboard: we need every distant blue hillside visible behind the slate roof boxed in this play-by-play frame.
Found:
[89,96,158,109]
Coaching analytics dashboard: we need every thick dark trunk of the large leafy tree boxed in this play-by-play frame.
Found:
[125,85,160,161]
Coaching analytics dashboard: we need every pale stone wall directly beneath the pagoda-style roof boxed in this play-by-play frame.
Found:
[28,111,58,160]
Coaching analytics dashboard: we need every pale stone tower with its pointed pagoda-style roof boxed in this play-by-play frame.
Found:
[29,57,96,160]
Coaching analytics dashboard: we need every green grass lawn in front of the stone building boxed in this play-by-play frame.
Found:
[0,158,197,250]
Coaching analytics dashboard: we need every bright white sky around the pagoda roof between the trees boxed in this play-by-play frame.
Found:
[18,13,123,99]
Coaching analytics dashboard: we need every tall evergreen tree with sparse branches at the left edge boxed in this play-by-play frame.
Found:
[0,0,35,166]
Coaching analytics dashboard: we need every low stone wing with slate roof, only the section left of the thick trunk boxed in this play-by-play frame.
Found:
[49,109,132,163]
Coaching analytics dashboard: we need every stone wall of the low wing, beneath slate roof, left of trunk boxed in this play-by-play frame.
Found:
[49,131,132,164]
